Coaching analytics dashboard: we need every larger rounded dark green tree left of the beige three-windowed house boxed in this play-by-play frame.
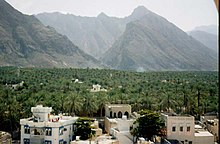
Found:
[131,110,164,139]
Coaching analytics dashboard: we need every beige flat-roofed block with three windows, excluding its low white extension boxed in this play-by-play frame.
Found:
[161,113,195,144]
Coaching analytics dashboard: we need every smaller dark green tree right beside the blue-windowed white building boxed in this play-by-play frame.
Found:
[76,118,95,140]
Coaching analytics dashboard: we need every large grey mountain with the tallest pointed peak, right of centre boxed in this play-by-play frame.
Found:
[102,7,217,71]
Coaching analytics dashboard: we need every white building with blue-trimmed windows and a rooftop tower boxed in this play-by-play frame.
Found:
[20,105,78,144]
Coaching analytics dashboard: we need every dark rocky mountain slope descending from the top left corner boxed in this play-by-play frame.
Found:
[0,0,101,68]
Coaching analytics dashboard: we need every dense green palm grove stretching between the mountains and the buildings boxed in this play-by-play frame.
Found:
[0,67,219,138]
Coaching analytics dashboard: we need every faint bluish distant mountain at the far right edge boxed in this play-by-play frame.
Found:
[188,30,218,52]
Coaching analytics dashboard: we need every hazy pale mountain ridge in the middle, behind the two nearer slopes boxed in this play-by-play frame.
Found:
[36,12,125,58]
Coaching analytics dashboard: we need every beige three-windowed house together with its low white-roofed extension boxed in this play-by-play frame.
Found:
[161,113,214,144]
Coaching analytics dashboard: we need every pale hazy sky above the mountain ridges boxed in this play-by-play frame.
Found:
[6,0,218,31]
